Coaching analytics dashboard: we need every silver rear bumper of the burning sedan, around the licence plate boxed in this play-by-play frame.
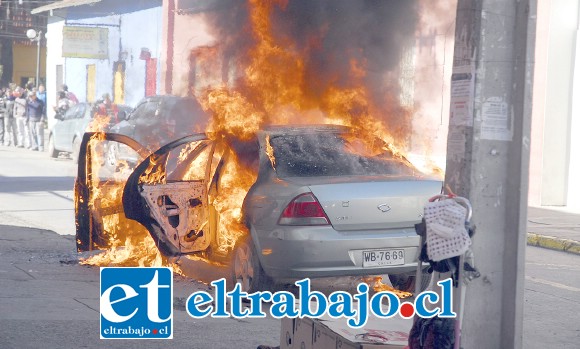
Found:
[252,226,420,279]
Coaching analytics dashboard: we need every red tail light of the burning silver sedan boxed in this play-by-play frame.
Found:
[278,193,330,225]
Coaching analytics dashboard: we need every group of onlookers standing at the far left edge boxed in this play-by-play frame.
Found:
[0,84,46,151]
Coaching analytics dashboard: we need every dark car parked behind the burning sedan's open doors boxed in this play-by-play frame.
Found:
[104,95,209,168]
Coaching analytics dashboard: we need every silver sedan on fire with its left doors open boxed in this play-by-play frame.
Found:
[75,125,442,292]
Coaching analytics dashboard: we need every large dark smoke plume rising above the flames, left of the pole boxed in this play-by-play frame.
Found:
[273,0,418,98]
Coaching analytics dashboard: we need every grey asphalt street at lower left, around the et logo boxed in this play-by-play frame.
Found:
[0,225,280,349]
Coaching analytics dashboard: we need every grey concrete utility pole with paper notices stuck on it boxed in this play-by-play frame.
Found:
[445,0,537,349]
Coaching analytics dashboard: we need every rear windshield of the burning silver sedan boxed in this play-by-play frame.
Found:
[270,133,415,177]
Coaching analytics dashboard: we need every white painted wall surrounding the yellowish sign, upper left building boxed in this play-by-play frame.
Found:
[47,6,162,110]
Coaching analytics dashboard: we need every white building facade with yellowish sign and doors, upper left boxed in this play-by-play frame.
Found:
[33,0,162,122]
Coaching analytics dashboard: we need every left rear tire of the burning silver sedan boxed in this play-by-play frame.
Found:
[231,238,273,293]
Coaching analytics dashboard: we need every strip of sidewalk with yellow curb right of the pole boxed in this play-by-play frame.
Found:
[528,207,580,254]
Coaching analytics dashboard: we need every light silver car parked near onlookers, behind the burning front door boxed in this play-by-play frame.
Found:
[48,103,131,163]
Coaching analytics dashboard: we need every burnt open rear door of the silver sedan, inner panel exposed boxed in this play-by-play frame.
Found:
[123,134,214,257]
